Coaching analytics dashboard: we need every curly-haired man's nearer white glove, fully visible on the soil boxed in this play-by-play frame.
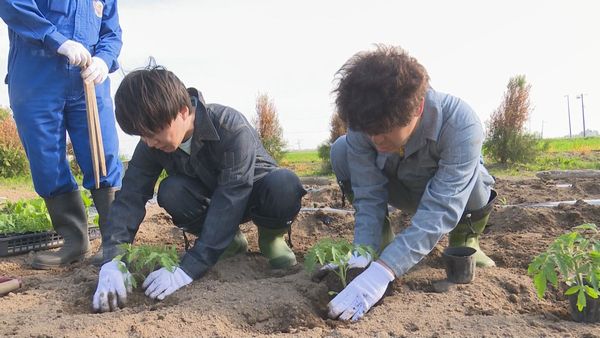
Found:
[327,262,394,321]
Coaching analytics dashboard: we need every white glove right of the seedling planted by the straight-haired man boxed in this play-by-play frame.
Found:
[142,268,192,300]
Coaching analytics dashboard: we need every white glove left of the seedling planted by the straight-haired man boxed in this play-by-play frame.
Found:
[92,261,131,312]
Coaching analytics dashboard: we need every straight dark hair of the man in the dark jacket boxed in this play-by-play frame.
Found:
[115,62,193,136]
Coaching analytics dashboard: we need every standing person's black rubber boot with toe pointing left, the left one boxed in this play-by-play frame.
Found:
[31,190,89,269]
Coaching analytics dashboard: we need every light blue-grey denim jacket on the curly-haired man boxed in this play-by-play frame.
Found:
[346,89,493,276]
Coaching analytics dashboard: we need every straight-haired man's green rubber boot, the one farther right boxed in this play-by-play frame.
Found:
[258,226,297,269]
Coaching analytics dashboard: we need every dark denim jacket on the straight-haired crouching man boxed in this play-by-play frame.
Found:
[102,88,277,279]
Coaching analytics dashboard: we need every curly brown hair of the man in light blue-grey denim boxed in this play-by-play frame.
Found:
[333,45,429,135]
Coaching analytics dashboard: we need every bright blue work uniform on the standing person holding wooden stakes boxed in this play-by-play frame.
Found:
[0,0,122,197]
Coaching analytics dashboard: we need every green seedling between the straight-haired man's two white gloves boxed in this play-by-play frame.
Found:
[113,243,179,288]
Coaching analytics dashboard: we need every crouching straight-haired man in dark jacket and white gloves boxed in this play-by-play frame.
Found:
[93,66,306,312]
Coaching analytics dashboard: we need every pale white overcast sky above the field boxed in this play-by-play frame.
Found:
[0,0,600,154]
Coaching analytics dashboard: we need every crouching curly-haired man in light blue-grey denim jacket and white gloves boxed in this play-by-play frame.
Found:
[324,45,496,320]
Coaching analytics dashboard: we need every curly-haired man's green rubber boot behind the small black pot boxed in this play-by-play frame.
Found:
[448,190,496,267]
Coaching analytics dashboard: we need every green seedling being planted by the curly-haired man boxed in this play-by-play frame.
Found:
[304,238,377,287]
